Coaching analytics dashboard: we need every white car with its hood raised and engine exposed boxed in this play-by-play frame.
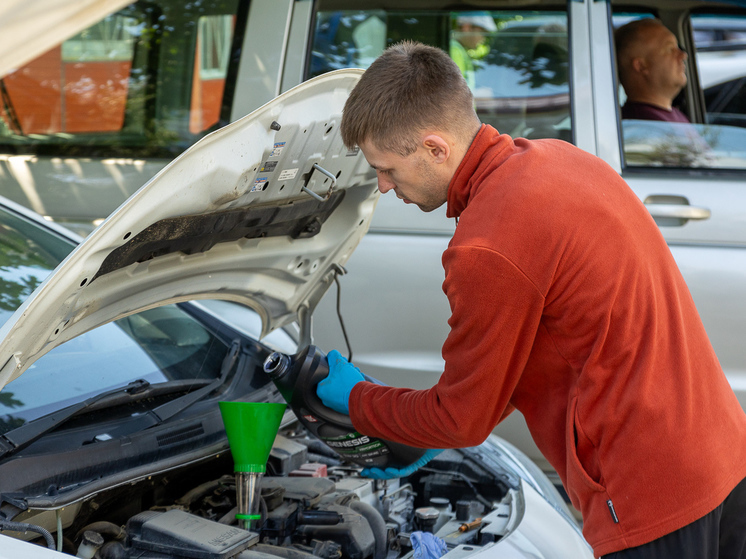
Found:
[0,5,592,559]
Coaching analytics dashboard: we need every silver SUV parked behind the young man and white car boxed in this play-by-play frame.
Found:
[0,0,746,476]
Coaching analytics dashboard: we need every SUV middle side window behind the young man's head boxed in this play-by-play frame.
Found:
[306,8,572,141]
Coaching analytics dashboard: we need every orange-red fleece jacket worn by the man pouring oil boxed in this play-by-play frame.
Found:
[349,125,746,556]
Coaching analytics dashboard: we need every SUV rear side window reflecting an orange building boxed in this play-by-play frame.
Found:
[0,0,239,157]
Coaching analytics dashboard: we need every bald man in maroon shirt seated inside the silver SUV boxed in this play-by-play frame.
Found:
[614,18,689,122]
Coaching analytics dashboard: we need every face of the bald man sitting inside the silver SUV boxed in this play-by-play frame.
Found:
[645,25,687,98]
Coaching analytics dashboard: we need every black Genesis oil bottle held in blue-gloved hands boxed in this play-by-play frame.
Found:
[264,345,425,469]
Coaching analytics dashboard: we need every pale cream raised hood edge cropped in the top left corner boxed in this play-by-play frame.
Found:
[0,0,132,78]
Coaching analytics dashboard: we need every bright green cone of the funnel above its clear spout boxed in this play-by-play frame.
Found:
[220,402,287,474]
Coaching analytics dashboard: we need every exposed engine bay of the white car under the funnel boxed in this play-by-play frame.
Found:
[0,423,522,559]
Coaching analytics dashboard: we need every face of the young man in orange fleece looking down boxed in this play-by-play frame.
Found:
[360,142,450,212]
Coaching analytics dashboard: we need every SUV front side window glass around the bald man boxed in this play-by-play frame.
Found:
[613,13,746,169]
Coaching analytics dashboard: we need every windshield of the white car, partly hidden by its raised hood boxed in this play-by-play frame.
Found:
[0,210,228,434]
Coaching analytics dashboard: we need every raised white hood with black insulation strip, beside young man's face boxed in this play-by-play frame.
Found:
[0,70,378,387]
